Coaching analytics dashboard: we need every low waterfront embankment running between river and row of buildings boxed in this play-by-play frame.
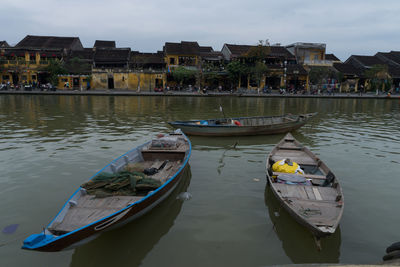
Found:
[0,90,400,99]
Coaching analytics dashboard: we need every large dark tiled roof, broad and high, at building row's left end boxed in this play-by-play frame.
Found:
[15,35,83,50]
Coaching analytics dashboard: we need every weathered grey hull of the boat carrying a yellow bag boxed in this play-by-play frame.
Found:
[266,134,344,238]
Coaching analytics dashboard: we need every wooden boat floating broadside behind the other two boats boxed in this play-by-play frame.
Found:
[169,113,316,136]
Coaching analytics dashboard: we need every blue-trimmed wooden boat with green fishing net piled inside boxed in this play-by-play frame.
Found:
[22,130,191,251]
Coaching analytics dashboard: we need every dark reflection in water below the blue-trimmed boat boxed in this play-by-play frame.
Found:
[71,166,191,267]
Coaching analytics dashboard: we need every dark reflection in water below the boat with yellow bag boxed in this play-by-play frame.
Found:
[265,185,341,264]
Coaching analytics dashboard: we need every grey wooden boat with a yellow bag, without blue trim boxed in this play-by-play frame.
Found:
[266,133,344,238]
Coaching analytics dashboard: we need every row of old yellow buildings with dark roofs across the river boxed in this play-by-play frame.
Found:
[0,35,400,91]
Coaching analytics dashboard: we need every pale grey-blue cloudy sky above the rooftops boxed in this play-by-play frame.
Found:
[0,0,400,60]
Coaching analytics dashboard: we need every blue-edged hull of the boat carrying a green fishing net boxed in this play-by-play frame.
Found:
[22,130,191,252]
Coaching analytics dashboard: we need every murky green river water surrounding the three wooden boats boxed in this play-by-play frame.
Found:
[0,95,400,266]
